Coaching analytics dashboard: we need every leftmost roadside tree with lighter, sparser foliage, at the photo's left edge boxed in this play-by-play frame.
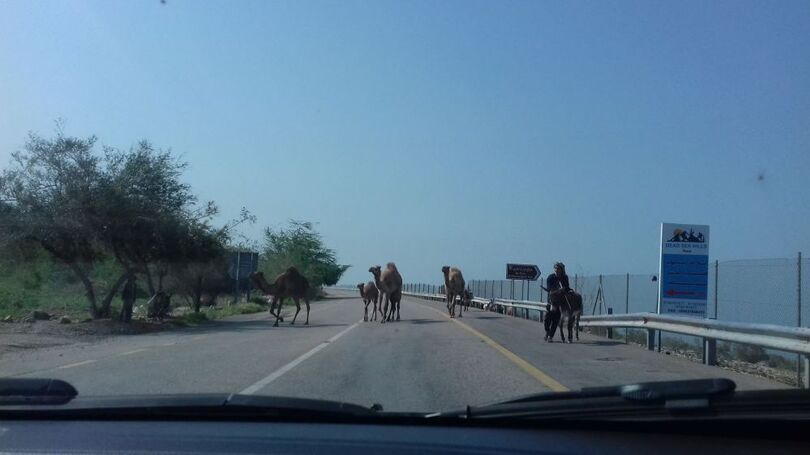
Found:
[0,130,112,318]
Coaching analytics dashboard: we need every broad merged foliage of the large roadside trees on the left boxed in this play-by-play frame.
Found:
[0,128,241,319]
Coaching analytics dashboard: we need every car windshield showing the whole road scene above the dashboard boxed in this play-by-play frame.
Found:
[0,0,810,412]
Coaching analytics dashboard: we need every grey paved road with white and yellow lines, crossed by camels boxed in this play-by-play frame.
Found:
[0,293,785,411]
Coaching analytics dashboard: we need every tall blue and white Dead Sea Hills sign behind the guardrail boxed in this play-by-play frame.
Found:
[658,223,709,318]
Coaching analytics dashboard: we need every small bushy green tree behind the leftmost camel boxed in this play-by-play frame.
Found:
[261,220,350,287]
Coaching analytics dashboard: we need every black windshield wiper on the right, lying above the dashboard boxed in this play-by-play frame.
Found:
[433,378,736,419]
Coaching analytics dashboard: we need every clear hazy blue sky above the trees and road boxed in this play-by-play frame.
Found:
[0,0,810,283]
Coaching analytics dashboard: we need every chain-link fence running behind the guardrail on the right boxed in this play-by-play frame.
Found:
[405,254,810,383]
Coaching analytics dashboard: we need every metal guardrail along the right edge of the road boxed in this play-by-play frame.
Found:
[403,292,810,388]
